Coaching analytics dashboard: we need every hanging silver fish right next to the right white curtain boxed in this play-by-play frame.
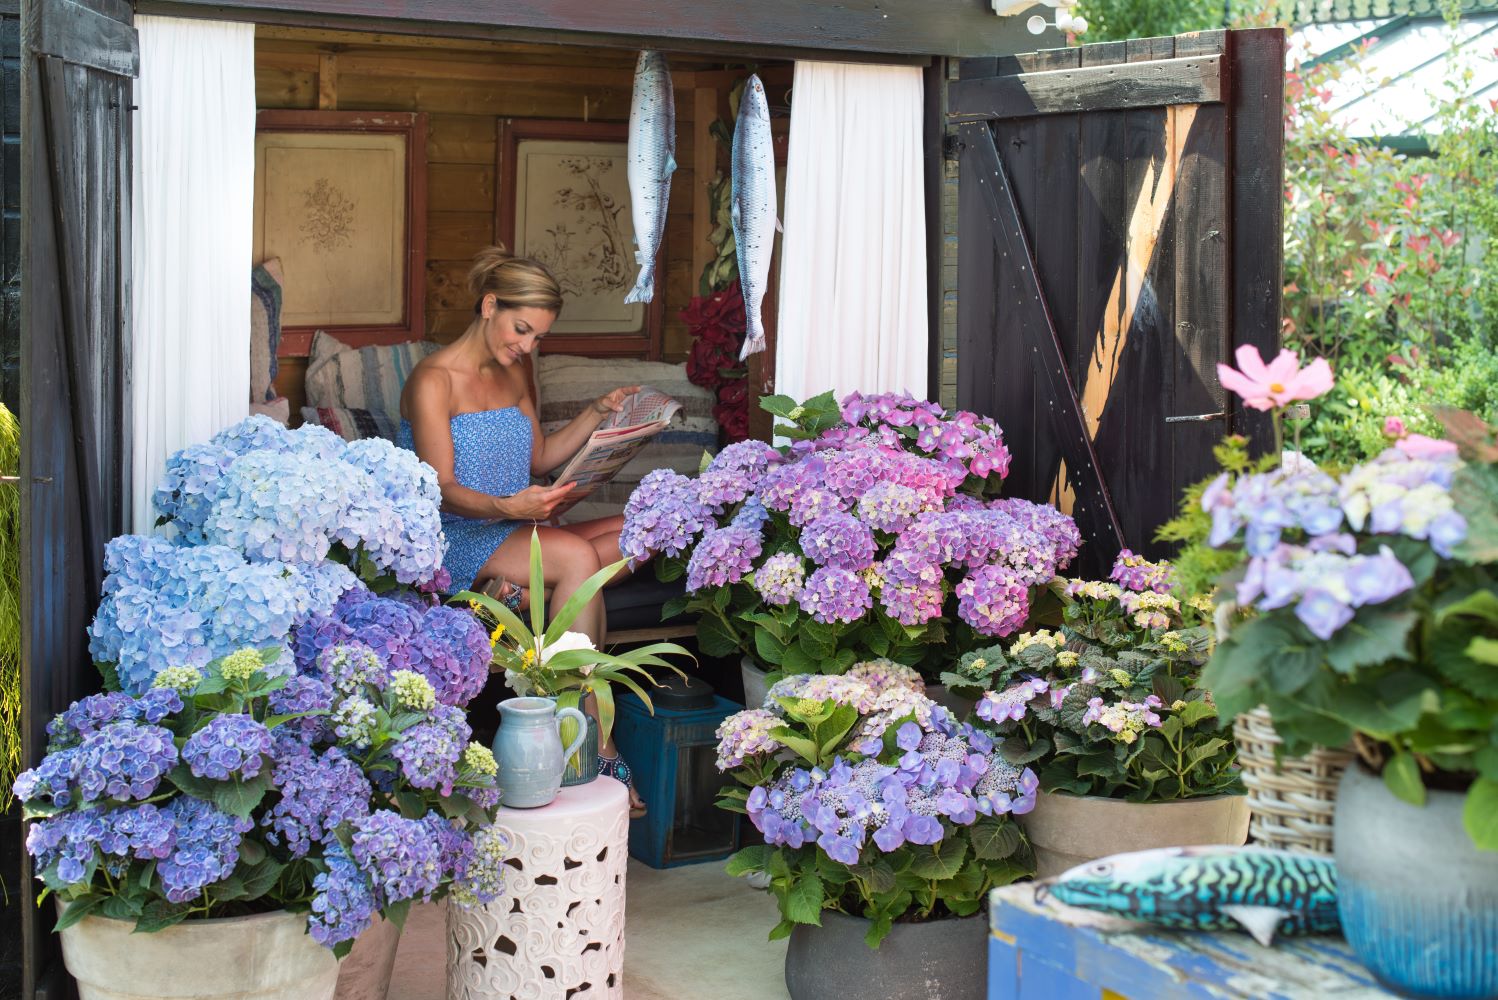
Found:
[730,75,780,361]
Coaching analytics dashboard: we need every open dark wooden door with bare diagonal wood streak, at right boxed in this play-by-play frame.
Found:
[947,28,1284,573]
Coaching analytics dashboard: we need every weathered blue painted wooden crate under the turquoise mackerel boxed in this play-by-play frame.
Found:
[989,885,1395,1000]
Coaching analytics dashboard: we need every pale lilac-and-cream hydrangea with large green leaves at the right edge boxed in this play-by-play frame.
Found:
[1203,412,1498,850]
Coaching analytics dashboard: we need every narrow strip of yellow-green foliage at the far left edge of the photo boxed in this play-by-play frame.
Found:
[0,406,21,813]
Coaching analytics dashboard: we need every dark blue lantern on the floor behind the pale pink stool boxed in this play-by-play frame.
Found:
[614,695,743,868]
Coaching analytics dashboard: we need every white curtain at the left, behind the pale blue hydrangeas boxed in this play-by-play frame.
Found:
[130,16,255,531]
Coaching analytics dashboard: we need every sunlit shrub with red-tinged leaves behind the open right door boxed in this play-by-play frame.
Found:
[1284,30,1498,372]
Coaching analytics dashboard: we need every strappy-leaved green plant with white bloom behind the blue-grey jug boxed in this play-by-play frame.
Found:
[454,531,692,746]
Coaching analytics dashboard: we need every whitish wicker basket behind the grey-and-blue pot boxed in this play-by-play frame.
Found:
[1233,707,1353,856]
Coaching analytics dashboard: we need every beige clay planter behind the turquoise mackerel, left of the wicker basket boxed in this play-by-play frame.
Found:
[1016,792,1248,879]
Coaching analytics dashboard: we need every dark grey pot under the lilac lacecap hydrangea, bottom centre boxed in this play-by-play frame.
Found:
[785,910,989,1000]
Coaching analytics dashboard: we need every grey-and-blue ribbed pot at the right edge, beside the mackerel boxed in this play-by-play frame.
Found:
[1335,763,1498,1000]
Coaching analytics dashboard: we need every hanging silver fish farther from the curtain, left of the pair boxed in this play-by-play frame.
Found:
[625,49,676,302]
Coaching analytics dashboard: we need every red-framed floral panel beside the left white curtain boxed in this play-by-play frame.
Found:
[255,111,427,356]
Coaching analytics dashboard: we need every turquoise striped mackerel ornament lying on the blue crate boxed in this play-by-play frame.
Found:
[1035,846,1339,946]
